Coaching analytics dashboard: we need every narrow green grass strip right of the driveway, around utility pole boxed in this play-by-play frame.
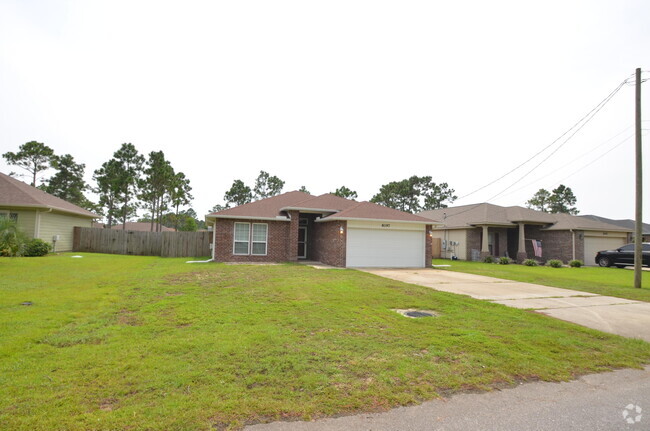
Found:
[433,259,650,302]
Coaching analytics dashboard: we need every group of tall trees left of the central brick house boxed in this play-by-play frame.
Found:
[3,141,195,231]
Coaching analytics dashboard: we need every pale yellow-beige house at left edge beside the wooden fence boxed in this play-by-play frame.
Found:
[0,172,100,251]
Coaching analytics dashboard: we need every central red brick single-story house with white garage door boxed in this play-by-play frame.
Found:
[206,191,434,268]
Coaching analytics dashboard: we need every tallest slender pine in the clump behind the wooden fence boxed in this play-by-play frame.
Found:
[113,143,144,230]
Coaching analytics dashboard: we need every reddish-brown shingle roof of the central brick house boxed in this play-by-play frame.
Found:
[206,191,433,224]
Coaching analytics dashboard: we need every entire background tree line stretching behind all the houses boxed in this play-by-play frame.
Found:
[3,141,578,223]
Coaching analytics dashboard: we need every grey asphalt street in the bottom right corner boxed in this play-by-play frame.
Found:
[246,367,650,431]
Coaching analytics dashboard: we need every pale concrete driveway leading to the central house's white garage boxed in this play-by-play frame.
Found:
[361,268,650,341]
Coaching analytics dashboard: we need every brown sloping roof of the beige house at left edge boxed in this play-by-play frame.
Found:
[0,172,100,218]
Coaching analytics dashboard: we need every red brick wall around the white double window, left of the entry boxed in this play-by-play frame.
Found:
[214,219,290,262]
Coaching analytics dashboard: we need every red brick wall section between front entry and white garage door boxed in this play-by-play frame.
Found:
[311,221,348,267]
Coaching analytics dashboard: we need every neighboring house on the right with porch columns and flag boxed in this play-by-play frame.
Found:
[418,203,631,265]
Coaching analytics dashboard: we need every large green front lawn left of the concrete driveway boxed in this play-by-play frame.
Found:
[0,254,650,430]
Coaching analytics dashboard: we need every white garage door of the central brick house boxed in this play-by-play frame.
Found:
[346,228,425,268]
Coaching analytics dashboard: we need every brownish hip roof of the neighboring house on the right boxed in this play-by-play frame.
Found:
[419,203,630,232]
